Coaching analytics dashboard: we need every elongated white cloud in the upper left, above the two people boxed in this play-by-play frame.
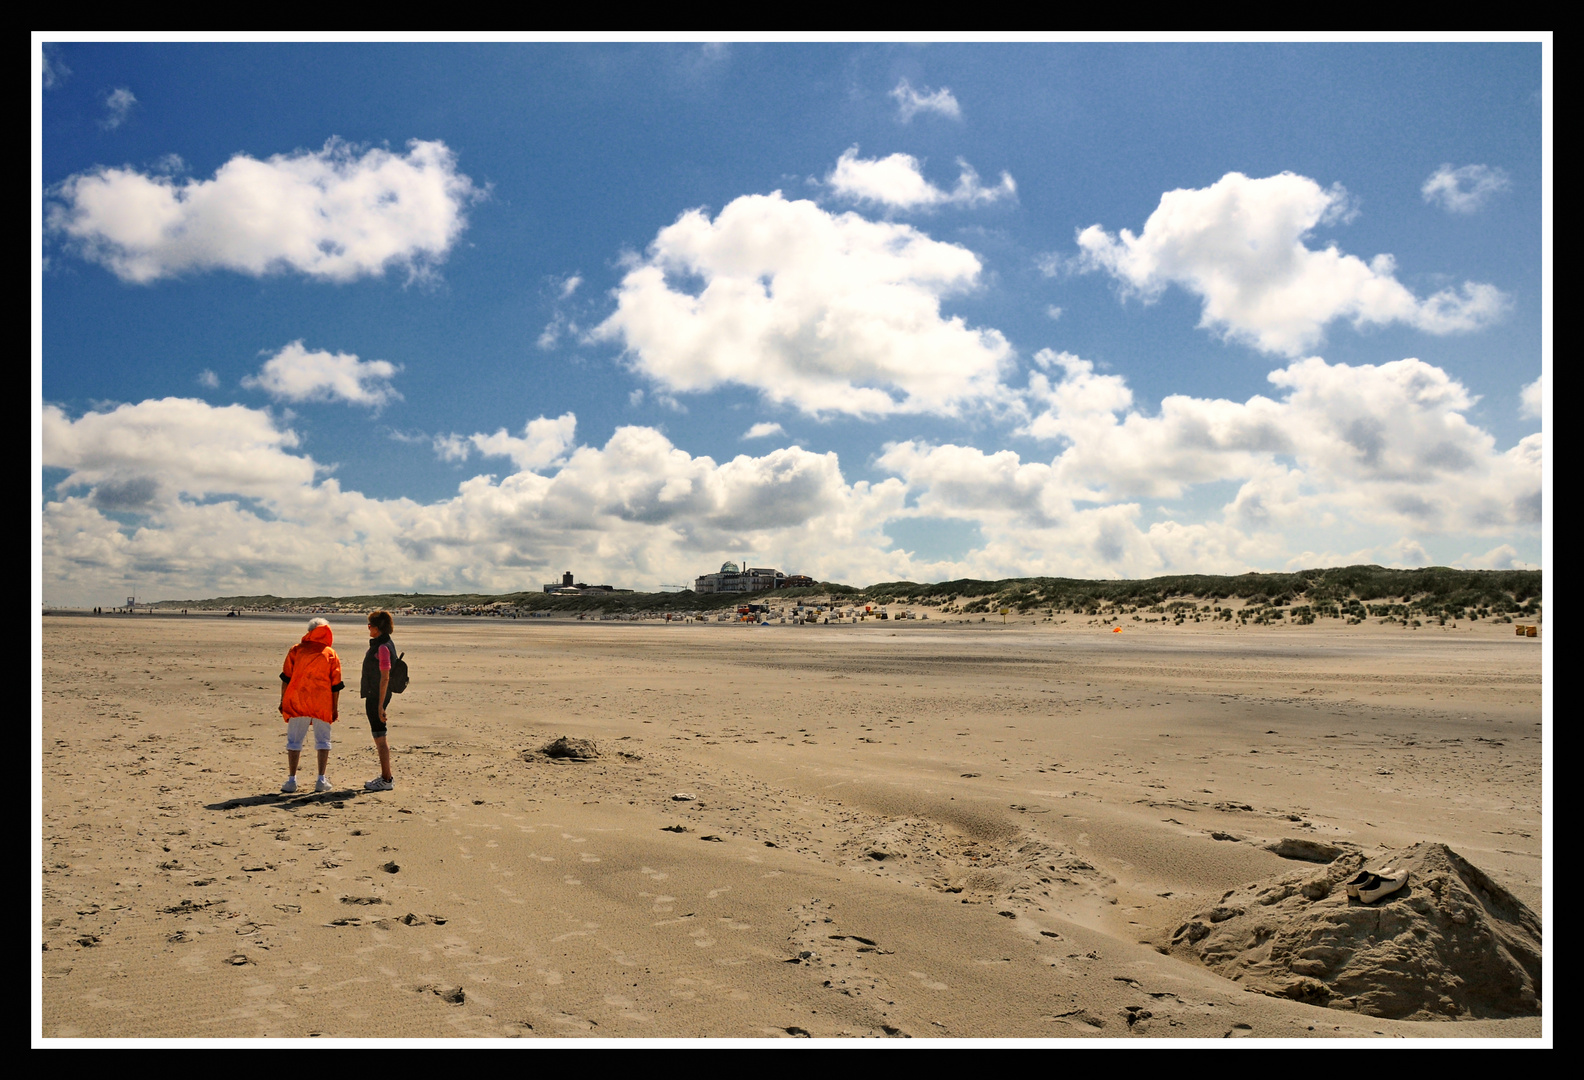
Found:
[49,139,480,283]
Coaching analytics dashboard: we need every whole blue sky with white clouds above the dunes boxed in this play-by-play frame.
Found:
[35,38,1549,605]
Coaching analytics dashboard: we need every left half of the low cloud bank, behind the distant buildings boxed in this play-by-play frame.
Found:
[43,399,903,603]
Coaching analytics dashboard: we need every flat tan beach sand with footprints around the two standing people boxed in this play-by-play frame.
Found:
[35,604,1541,1039]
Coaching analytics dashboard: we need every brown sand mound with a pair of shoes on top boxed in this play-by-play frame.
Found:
[1171,844,1541,1020]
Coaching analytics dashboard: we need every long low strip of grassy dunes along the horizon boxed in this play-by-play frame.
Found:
[154,565,1541,626]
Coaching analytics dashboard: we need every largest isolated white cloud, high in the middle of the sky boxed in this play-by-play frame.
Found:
[594,192,1012,416]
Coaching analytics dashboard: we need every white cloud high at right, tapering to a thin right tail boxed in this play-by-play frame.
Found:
[1077,173,1508,356]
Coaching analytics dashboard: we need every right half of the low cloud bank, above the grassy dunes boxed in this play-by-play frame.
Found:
[855,350,1541,580]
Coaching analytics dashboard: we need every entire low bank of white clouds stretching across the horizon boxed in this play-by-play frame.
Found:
[43,352,1541,603]
